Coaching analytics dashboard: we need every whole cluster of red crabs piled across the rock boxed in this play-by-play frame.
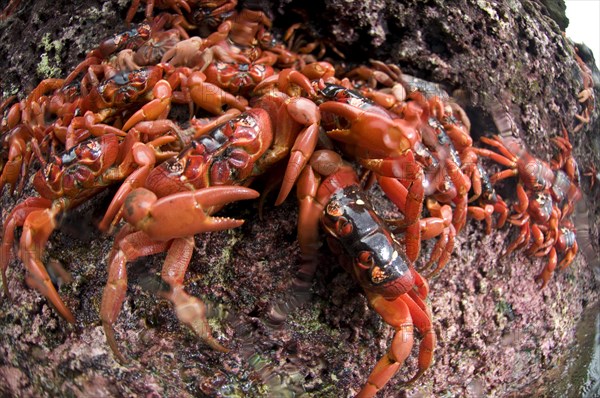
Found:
[0,0,594,397]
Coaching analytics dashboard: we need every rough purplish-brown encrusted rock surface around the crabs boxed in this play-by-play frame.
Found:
[0,0,600,397]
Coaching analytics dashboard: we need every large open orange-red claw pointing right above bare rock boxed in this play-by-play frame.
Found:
[123,186,259,240]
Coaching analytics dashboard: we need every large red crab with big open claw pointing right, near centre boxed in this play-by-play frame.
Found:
[95,87,319,361]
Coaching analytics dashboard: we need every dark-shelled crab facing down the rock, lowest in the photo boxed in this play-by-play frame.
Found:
[297,150,436,397]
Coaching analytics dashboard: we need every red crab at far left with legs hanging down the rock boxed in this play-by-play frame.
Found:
[0,134,164,322]
